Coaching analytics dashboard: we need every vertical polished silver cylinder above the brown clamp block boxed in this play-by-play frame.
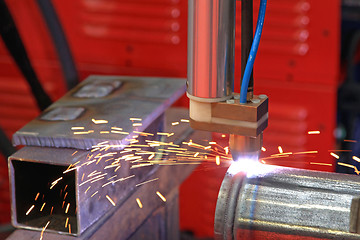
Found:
[187,0,236,101]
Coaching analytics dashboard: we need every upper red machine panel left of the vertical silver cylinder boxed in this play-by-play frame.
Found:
[55,0,187,77]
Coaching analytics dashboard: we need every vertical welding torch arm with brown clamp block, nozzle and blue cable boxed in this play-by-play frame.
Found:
[187,0,268,160]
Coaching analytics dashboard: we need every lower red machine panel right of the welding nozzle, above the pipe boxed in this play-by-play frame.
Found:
[256,80,337,172]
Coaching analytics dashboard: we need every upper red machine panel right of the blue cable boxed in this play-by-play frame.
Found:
[235,0,340,85]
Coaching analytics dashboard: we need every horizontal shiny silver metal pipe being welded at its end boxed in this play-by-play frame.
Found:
[215,160,360,240]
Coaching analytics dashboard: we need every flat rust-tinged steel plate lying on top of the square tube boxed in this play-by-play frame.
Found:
[13,76,185,149]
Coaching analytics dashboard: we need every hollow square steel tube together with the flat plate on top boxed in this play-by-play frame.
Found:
[9,76,185,236]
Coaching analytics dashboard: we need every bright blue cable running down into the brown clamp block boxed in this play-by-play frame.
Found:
[240,0,267,104]
